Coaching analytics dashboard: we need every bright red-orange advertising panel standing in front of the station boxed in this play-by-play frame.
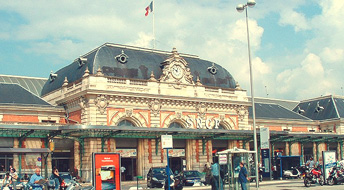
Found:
[92,153,121,190]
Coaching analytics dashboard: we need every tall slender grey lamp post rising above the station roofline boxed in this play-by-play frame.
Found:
[236,0,259,189]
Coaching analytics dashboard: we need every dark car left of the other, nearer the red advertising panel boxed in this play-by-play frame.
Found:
[147,167,172,188]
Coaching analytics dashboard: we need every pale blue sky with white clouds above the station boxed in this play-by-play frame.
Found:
[0,0,344,101]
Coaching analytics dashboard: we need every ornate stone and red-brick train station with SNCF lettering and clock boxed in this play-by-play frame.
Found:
[0,43,344,181]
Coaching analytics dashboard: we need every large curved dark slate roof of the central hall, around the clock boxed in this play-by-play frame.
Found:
[42,43,235,95]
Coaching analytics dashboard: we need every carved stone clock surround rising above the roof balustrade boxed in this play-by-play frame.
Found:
[159,48,194,85]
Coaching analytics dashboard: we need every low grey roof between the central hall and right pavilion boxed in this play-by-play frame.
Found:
[249,103,311,121]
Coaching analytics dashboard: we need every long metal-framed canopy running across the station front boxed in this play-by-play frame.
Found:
[0,124,344,143]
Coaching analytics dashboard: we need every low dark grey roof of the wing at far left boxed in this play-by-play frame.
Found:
[0,83,51,106]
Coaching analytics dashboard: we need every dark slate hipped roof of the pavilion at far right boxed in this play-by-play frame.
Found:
[293,95,344,120]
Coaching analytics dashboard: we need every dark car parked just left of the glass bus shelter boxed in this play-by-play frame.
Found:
[179,170,206,186]
